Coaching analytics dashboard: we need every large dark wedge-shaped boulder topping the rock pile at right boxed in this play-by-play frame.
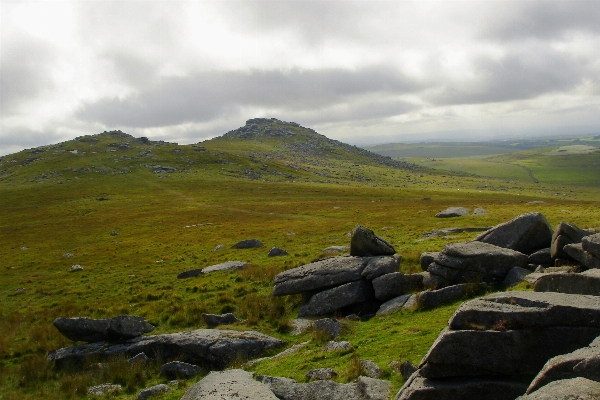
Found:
[475,212,552,254]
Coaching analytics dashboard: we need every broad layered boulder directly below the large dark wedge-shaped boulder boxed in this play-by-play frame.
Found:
[427,241,527,284]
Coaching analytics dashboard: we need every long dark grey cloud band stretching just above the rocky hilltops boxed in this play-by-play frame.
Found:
[77,67,419,127]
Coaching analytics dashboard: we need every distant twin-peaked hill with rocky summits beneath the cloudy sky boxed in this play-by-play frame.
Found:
[0,118,417,183]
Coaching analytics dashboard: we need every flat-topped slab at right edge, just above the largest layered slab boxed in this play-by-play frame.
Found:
[533,269,600,296]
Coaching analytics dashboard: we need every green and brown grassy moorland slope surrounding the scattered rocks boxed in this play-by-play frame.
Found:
[0,129,600,399]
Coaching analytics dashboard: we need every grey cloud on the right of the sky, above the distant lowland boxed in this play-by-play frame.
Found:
[425,50,595,104]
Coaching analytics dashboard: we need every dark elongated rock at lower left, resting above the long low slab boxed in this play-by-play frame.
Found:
[53,315,154,342]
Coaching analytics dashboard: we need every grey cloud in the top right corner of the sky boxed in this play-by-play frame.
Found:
[485,0,600,40]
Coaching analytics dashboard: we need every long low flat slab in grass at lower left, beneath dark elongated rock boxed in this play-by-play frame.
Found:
[48,329,285,369]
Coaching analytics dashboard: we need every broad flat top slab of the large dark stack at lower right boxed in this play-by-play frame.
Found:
[448,291,600,330]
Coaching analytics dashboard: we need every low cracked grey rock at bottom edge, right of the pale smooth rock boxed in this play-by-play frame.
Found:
[257,376,391,400]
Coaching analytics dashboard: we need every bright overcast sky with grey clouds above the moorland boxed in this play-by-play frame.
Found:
[0,0,600,155]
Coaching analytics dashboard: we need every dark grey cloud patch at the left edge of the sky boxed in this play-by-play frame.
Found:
[0,36,54,116]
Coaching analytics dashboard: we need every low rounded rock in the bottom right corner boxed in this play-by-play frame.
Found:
[517,378,600,400]
